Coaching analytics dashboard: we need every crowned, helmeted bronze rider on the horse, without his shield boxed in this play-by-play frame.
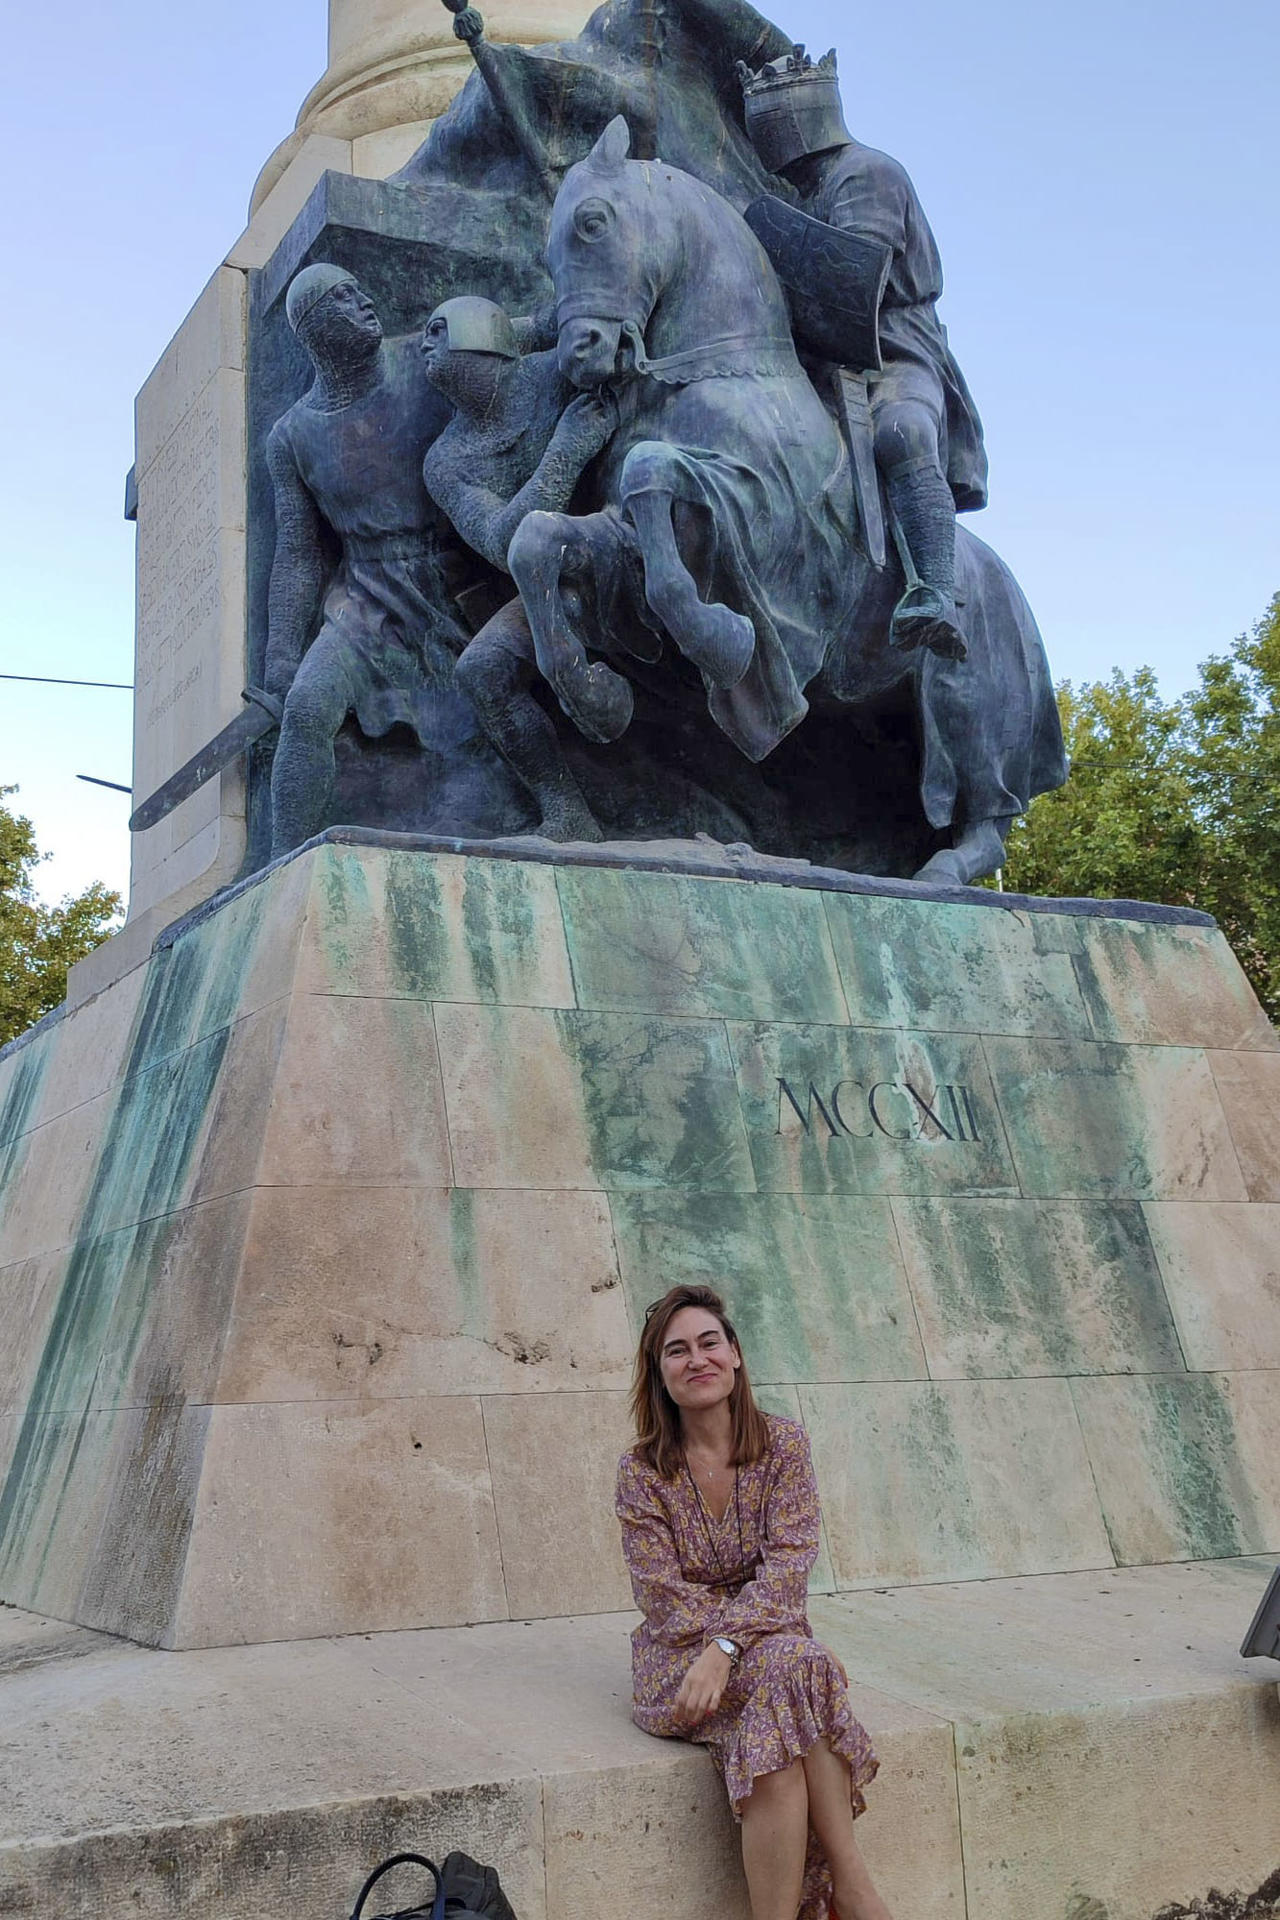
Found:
[737,46,986,657]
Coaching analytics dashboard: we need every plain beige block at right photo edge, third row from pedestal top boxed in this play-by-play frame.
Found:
[1144,1200,1280,1373]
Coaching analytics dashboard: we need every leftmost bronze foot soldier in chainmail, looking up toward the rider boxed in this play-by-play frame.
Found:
[265,265,466,856]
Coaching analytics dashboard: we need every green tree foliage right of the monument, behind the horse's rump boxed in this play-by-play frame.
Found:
[1004,593,1280,1020]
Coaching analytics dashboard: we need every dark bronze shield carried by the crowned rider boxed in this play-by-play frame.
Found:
[743,194,892,372]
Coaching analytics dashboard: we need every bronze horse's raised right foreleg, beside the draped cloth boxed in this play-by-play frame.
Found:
[622,440,756,687]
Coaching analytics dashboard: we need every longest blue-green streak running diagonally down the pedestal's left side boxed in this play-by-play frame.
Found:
[0,910,259,1605]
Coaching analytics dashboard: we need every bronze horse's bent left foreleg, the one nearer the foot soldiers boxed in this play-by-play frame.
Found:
[507,513,635,745]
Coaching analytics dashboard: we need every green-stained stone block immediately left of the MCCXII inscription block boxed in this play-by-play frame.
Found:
[555,1010,756,1192]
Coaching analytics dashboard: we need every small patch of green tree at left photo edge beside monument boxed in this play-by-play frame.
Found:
[0,787,123,1044]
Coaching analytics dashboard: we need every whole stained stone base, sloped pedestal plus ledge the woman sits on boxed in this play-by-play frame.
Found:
[0,848,1280,1920]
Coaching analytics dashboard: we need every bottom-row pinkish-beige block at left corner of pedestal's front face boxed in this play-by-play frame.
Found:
[167,1396,507,1647]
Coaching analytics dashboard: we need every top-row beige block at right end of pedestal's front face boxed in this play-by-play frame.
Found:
[1075,920,1280,1050]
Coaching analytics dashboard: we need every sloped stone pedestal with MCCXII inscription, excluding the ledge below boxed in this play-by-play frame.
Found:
[0,837,1280,1647]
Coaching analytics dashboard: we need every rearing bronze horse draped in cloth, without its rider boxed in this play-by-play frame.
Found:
[509,119,1065,883]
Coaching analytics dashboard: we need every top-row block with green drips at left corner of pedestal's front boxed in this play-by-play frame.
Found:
[297,847,574,1006]
